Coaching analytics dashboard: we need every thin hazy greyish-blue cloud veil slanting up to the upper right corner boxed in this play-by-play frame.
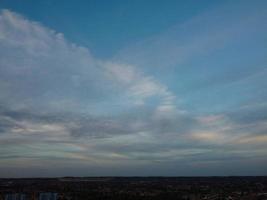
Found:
[115,2,266,70]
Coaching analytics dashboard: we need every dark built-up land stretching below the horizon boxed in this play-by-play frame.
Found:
[0,177,267,200]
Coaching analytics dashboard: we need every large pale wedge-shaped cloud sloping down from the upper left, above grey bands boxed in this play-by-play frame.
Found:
[0,10,178,111]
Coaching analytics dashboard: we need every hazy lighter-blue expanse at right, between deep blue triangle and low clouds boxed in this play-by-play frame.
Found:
[114,2,267,112]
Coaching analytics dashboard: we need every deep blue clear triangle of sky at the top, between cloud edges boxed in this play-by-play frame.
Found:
[1,0,220,58]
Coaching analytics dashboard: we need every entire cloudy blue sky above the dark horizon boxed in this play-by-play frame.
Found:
[0,0,267,177]
